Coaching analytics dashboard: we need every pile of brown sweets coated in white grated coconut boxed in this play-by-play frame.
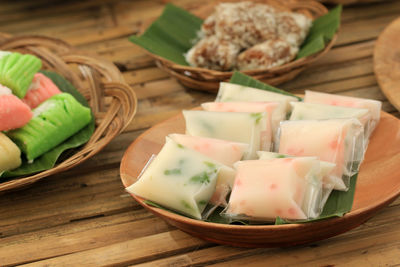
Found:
[186,2,312,71]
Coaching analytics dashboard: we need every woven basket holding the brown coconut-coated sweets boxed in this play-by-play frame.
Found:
[146,0,337,92]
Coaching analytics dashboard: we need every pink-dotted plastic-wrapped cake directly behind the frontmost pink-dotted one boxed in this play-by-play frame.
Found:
[278,119,365,191]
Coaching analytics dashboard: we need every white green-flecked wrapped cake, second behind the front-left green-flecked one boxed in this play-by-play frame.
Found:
[183,110,271,159]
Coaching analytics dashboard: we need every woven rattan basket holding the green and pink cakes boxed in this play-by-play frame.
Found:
[0,33,137,191]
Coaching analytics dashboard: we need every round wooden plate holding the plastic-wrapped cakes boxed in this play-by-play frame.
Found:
[120,112,400,247]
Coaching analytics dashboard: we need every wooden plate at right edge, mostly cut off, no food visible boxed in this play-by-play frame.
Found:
[374,18,400,110]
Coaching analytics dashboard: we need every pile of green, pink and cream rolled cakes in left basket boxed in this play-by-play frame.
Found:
[0,51,92,176]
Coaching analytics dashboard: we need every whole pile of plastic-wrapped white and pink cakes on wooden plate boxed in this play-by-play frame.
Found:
[127,83,381,221]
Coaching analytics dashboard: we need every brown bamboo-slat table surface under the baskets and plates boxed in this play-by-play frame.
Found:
[0,0,400,266]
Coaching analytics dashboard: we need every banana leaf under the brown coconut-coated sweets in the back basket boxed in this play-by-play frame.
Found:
[129,4,342,66]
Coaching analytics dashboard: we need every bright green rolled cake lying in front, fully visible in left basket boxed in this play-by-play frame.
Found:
[7,93,92,161]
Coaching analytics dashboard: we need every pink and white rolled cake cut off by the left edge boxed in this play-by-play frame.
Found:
[0,85,33,131]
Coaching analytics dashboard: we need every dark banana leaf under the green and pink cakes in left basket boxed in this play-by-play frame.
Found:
[0,71,95,178]
